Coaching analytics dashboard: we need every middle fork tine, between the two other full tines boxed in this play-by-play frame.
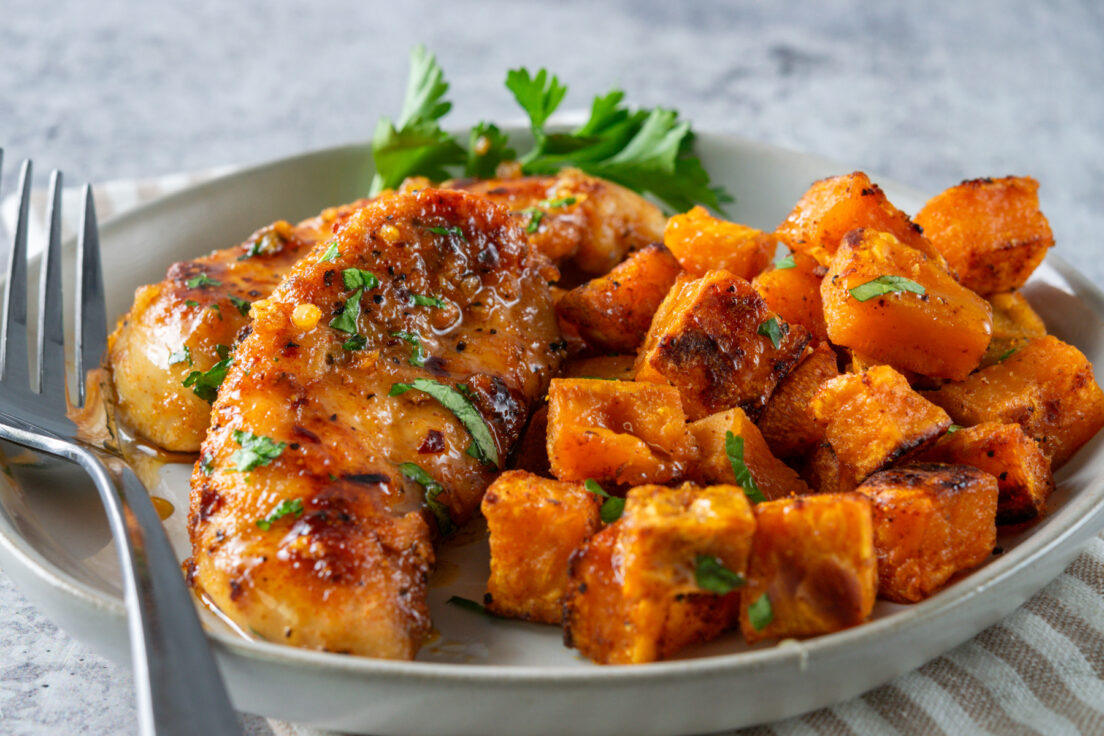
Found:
[35,169,65,410]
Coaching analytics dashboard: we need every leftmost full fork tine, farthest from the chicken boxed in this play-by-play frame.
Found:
[0,160,32,392]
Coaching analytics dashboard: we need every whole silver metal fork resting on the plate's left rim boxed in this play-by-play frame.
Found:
[0,149,242,735]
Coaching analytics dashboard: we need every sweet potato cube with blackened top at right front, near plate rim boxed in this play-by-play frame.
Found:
[857,463,997,602]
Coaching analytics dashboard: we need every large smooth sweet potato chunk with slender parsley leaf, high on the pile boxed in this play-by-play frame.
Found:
[820,230,992,381]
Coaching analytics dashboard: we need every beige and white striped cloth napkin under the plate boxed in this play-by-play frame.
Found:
[0,167,1104,736]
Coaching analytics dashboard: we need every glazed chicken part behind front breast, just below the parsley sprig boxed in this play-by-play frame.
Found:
[446,169,667,276]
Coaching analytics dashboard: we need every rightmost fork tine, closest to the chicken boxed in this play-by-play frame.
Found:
[74,184,107,406]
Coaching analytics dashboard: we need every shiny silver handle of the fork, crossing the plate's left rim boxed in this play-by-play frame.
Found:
[72,447,242,736]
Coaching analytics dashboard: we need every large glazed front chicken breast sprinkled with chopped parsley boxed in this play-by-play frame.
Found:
[189,189,563,659]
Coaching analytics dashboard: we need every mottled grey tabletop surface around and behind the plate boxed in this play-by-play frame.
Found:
[0,0,1104,734]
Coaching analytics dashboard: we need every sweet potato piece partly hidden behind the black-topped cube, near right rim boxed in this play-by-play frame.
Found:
[917,422,1054,524]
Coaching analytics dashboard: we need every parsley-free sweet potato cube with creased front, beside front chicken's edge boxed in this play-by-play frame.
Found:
[548,378,697,486]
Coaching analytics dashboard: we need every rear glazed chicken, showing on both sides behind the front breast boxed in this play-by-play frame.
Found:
[109,169,666,452]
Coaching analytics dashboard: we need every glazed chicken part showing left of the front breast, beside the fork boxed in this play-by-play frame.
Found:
[108,200,368,452]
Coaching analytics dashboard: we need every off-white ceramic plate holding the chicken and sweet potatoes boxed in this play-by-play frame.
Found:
[0,136,1104,735]
